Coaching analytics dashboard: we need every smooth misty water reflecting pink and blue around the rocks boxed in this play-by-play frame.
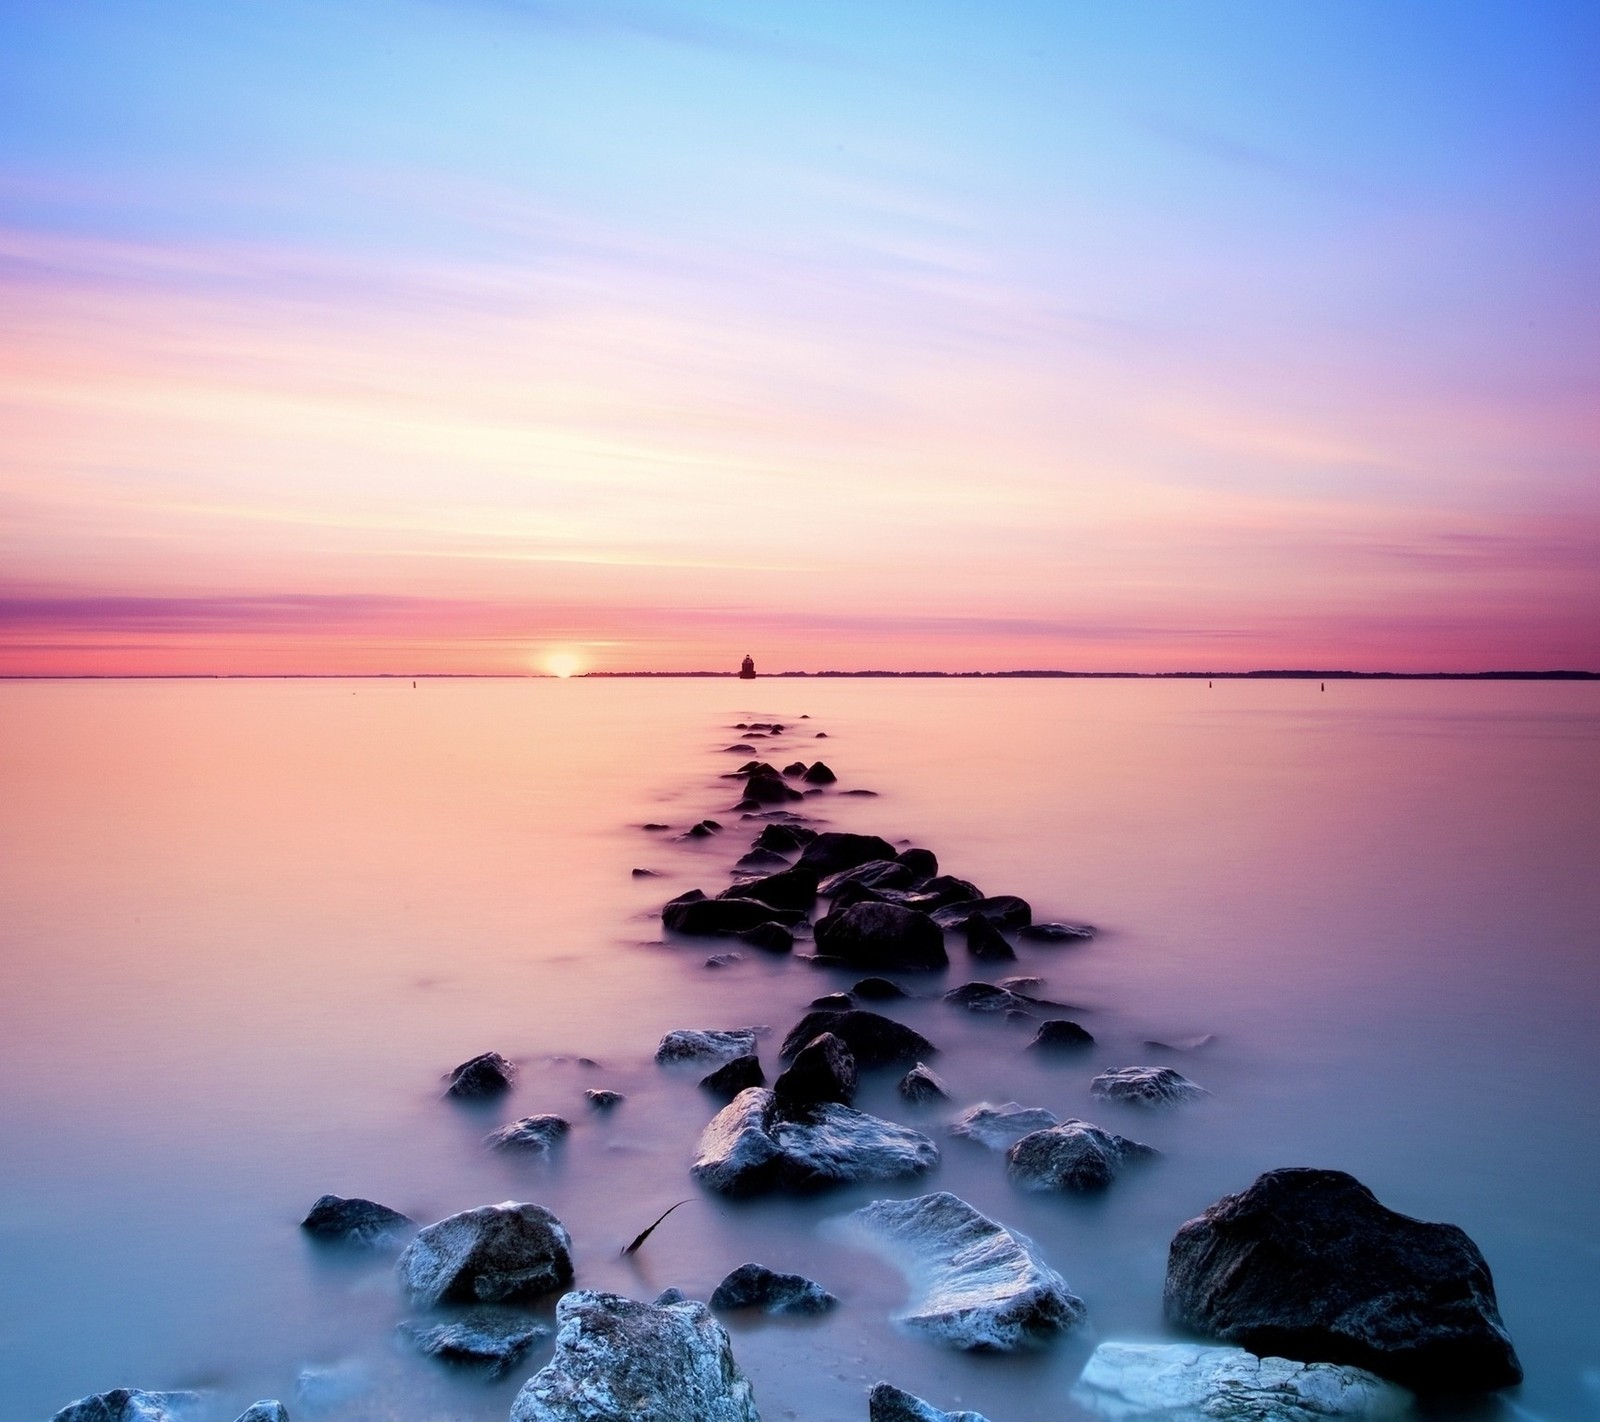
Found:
[0,680,1600,1422]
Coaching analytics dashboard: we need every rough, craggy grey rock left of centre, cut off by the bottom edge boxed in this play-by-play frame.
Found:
[510,1289,760,1422]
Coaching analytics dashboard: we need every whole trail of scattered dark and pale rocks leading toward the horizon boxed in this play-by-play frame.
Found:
[53,721,1522,1422]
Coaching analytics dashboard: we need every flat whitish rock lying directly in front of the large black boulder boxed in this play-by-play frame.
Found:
[1072,1344,1413,1422]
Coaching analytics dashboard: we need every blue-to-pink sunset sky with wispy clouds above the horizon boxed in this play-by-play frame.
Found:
[0,0,1600,675]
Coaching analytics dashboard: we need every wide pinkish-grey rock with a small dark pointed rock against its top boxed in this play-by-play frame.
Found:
[690,1088,939,1195]
